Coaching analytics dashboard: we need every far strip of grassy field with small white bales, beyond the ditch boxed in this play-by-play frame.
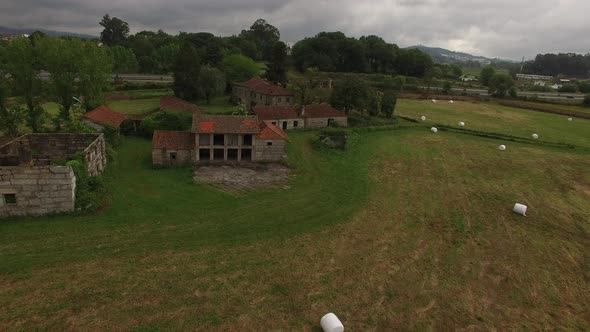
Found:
[396,99,590,148]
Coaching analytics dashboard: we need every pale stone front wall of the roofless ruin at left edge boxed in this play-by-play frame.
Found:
[0,166,76,217]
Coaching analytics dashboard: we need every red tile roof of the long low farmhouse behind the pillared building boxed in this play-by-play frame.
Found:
[254,104,346,121]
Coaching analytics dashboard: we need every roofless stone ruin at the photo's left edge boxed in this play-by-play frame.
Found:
[0,134,107,217]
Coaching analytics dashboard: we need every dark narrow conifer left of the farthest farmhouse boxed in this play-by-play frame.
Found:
[172,43,201,100]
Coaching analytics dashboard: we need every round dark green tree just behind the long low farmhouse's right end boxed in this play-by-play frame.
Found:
[330,76,369,114]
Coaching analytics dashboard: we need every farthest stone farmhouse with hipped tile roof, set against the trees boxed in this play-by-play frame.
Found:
[232,77,295,107]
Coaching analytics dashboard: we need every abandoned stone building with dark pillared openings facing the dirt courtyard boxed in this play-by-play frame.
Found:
[152,113,288,166]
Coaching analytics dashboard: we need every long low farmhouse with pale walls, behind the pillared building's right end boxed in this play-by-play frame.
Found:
[254,104,348,130]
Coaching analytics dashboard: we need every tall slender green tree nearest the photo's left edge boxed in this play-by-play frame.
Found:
[5,37,44,132]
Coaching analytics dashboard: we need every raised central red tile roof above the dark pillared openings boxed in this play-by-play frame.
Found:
[193,114,260,134]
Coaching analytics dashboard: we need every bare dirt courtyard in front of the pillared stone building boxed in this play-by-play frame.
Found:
[193,163,289,193]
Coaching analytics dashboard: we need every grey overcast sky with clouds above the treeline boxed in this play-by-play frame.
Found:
[0,0,590,59]
